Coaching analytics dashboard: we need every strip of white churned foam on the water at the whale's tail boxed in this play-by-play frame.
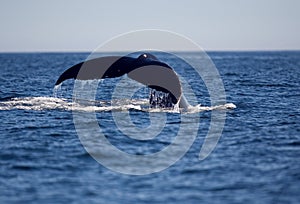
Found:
[0,97,236,113]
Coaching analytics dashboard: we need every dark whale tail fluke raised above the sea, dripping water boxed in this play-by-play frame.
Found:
[55,53,188,107]
